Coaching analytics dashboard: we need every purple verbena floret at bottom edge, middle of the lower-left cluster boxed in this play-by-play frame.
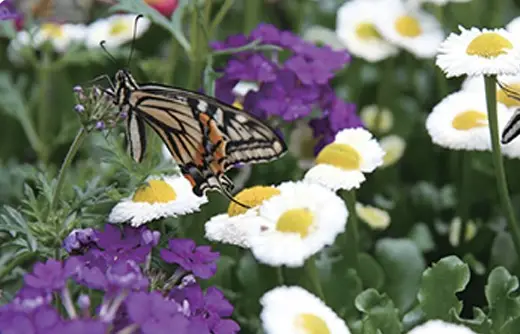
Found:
[125,292,189,334]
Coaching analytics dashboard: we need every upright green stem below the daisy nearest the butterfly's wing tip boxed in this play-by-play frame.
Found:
[345,190,359,270]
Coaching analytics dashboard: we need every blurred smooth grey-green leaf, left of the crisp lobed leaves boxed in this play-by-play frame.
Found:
[375,239,426,313]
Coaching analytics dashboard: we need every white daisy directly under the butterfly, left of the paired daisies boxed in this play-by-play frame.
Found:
[108,175,208,227]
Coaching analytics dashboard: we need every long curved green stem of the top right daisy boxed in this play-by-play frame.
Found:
[484,75,520,255]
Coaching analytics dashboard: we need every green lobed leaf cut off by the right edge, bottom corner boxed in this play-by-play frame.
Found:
[485,267,520,333]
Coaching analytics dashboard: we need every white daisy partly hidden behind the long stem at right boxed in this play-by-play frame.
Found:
[426,90,509,151]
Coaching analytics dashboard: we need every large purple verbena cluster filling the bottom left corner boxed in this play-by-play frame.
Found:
[0,225,240,334]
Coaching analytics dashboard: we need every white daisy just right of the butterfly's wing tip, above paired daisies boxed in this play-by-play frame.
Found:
[305,128,385,191]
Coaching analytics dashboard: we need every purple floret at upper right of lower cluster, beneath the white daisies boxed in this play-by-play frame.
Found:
[161,239,219,279]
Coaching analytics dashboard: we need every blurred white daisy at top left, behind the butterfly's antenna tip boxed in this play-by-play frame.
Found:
[85,14,150,48]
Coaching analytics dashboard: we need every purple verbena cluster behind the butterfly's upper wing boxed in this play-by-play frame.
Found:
[211,24,362,151]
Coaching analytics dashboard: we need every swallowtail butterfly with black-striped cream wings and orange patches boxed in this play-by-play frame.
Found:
[107,70,287,196]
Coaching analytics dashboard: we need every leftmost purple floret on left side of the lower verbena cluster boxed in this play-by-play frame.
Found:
[24,258,79,291]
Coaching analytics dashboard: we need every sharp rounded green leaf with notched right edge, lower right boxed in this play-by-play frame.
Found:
[418,256,470,321]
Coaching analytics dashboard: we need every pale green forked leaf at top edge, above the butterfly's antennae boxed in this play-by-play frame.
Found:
[110,0,191,55]
